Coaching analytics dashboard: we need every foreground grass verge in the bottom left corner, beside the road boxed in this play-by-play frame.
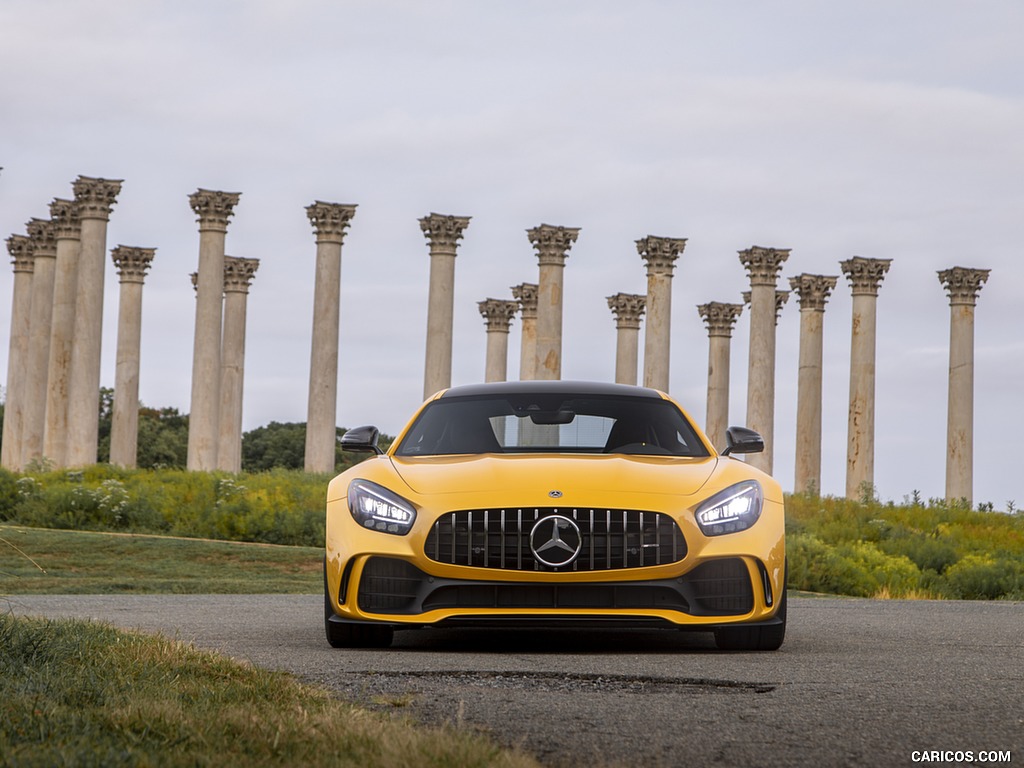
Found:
[0,615,538,768]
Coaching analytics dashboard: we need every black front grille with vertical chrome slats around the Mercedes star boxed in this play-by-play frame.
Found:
[424,507,686,571]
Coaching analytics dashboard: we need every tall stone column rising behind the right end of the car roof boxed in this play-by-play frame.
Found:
[636,236,686,392]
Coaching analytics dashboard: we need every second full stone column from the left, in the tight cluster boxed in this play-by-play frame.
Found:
[22,219,57,468]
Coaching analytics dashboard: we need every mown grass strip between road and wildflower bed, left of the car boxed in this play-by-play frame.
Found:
[0,525,324,595]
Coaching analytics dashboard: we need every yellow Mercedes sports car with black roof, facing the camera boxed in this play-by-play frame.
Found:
[324,381,785,650]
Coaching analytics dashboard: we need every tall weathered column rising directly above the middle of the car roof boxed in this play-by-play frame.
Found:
[526,224,580,381]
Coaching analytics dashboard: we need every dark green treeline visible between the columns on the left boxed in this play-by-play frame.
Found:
[0,387,393,472]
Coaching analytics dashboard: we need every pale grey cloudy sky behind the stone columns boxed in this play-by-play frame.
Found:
[0,0,1024,508]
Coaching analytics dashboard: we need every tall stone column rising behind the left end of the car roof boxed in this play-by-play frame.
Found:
[420,213,470,398]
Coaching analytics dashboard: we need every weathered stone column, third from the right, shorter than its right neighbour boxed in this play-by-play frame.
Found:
[790,273,839,494]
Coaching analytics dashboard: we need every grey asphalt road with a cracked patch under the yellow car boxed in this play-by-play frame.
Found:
[6,595,1024,768]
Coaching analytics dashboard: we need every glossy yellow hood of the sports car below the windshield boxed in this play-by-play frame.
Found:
[391,454,718,506]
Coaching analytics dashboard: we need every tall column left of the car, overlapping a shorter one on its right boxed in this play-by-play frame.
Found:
[187,189,242,471]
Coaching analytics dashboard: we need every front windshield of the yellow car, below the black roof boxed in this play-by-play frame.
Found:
[395,393,709,457]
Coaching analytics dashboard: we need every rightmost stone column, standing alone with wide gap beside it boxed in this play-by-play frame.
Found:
[939,266,991,506]
